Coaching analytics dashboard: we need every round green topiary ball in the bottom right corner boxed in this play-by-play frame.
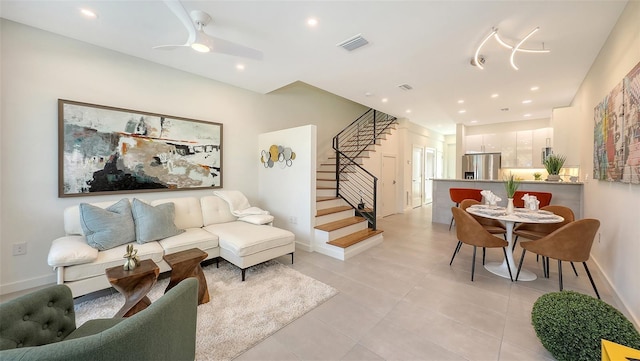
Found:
[531,291,640,361]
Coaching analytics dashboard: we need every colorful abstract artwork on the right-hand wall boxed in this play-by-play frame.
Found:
[593,63,640,184]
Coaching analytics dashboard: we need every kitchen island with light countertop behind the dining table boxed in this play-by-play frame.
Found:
[431,179,584,224]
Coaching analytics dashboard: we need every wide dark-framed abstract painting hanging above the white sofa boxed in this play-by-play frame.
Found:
[58,99,222,197]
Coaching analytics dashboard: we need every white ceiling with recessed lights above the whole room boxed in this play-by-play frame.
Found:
[0,0,626,134]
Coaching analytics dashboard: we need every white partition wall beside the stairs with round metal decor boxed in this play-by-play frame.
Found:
[256,125,317,251]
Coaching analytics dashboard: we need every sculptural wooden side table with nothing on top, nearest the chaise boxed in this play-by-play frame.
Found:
[163,248,209,305]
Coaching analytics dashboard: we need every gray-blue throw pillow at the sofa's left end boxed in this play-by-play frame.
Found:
[80,198,136,251]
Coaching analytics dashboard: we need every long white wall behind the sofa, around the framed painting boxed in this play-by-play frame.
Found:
[0,19,366,294]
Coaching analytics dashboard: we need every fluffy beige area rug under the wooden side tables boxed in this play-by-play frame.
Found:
[75,261,338,360]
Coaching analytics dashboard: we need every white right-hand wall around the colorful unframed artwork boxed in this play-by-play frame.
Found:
[553,1,640,325]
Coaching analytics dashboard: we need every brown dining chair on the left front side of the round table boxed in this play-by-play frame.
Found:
[449,207,513,282]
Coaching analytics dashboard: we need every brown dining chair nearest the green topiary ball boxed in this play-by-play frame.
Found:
[516,219,600,298]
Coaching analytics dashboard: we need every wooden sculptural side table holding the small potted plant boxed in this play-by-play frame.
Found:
[105,259,160,317]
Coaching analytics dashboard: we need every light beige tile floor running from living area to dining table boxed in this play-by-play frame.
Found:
[236,206,622,361]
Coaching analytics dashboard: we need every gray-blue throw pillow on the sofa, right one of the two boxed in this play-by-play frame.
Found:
[133,198,184,244]
